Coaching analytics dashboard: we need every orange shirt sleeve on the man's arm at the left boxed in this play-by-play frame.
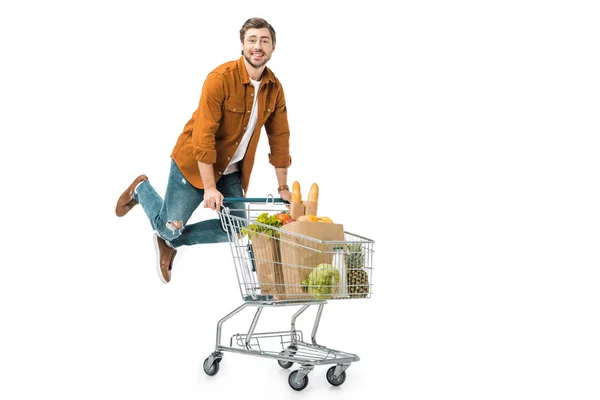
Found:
[192,72,225,164]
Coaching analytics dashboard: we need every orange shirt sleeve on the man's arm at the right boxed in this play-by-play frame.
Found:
[265,86,292,168]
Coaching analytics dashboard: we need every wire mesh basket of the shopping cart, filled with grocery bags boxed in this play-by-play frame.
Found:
[220,202,374,303]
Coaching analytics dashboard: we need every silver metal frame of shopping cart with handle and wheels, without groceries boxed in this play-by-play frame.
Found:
[203,196,373,391]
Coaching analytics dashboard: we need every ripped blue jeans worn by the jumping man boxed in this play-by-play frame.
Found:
[134,160,246,247]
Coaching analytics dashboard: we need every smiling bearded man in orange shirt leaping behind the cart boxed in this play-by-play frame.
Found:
[116,18,291,283]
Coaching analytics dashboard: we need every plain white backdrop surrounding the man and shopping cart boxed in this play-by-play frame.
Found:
[0,0,600,399]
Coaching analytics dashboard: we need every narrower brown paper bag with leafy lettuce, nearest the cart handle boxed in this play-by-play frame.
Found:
[252,234,284,300]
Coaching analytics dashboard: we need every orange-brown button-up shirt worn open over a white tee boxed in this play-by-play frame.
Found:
[171,57,292,193]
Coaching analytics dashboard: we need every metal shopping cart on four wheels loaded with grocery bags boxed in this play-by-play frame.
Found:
[203,196,374,391]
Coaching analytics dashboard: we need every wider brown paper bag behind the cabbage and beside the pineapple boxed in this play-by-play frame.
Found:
[279,221,344,300]
